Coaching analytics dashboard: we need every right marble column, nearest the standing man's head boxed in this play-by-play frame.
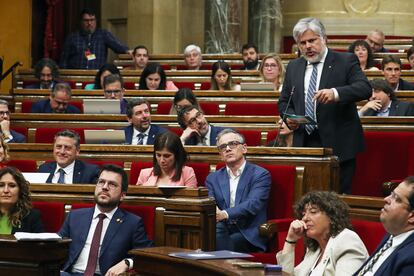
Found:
[249,0,282,53]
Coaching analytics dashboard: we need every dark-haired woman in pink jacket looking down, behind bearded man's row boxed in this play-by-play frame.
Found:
[137,131,197,188]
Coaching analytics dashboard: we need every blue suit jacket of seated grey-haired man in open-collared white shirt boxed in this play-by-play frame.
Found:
[206,162,272,251]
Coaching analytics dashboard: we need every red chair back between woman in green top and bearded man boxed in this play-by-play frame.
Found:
[32,201,65,233]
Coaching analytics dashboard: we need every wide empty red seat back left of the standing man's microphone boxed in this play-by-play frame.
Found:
[224,102,279,116]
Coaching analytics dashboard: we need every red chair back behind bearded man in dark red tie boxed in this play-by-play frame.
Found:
[72,203,155,240]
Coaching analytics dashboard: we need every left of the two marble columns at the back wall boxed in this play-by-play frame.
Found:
[205,0,242,53]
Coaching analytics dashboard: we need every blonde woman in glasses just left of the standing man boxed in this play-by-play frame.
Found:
[259,54,285,91]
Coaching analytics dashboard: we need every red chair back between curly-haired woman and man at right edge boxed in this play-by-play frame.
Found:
[351,219,386,255]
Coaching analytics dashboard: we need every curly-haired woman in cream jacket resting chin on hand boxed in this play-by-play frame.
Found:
[276,191,368,276]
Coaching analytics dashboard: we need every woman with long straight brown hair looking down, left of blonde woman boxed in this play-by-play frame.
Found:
[210,60,240,91]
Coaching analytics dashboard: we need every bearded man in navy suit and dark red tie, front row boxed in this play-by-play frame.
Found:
[59,164,152,276]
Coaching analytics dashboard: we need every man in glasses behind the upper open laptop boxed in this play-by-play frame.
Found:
[103,74,128,114]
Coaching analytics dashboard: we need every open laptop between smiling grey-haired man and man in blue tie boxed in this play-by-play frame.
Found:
[83,129,125,144]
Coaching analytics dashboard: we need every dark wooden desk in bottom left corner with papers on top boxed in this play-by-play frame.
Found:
[0,235,71,276]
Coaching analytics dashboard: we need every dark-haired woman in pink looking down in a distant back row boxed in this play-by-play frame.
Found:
[139,62,178,91]
